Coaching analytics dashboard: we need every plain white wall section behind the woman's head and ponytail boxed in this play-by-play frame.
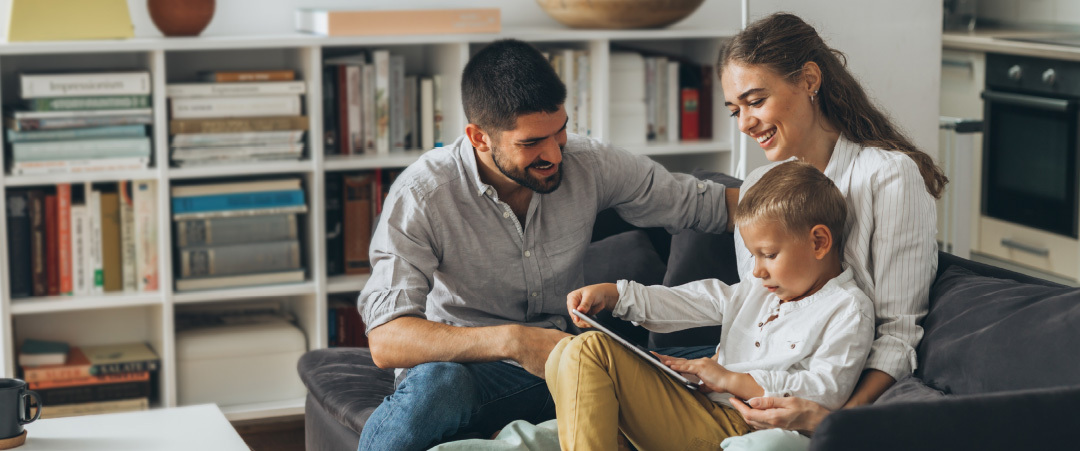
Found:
[747,0,942,169]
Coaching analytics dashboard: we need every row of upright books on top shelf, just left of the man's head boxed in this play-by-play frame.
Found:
[323,50,443,155]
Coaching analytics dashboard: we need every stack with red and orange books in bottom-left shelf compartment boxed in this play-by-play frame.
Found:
[19,339,159,419]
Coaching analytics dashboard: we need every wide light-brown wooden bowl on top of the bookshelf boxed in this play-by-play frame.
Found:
[537,0,704,29]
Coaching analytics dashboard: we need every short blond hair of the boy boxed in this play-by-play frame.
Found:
[734,161,848,250]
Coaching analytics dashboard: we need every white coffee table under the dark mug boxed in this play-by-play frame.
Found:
[15,405,249,451]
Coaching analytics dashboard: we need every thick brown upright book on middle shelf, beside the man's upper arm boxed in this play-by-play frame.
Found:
[342,173,377,274]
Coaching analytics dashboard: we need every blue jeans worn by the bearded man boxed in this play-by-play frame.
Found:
[357,346,716,451]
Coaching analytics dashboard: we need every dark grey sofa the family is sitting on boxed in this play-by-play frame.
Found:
[298,176,1080,450]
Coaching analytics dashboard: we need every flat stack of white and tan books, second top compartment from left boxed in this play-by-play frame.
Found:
[166,70,308,167]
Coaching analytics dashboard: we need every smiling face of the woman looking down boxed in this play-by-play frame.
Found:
[720,63,815,161]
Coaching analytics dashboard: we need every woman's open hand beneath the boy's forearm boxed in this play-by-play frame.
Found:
[731,397,831,436]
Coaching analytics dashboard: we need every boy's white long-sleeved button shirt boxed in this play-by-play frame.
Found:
[612,265,874,409]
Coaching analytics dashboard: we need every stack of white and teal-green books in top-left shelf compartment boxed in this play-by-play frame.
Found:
[5,71,153,175]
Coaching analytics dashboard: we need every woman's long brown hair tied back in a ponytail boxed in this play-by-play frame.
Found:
[716,13,948,197]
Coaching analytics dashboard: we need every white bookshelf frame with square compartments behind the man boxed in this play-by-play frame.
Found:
[0,27,737,421]
